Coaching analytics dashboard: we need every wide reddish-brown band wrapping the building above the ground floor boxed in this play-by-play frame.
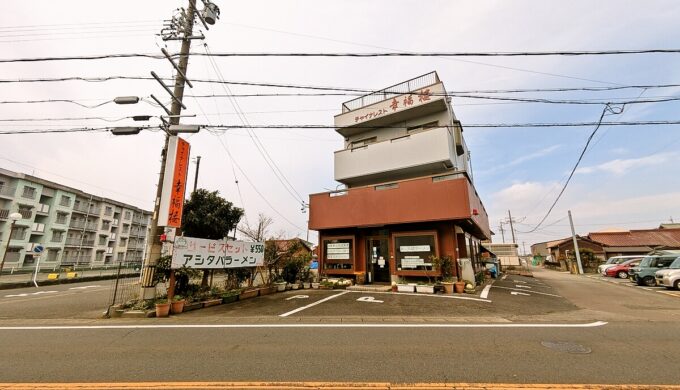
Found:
[309,173,491,238]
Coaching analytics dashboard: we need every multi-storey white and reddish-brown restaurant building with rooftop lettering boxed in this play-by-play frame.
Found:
[309,72,491,283]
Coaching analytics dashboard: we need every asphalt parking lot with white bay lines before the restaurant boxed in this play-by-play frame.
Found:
[173,275,576,322]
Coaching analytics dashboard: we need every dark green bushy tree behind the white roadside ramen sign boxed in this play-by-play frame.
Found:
[182,188,243,287]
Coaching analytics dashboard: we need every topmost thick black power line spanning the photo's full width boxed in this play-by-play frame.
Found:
[0,49,680,63]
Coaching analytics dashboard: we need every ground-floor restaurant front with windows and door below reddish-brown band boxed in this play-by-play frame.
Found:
[319,221,480,283]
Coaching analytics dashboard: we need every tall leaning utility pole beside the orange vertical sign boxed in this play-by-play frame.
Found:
[141,0,201,300]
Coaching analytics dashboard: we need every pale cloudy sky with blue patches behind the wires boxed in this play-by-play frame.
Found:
[0,0,680,250]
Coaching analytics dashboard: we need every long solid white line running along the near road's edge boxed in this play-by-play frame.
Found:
[0,321,607,331]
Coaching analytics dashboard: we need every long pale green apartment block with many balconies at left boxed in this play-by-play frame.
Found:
[0,168,151,269]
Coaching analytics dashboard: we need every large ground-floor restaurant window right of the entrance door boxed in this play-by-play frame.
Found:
[394,233,437,271]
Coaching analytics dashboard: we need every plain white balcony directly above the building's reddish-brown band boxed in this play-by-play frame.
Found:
[335,126,456,185]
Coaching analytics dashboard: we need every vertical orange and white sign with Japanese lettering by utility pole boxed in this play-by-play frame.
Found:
[158,136,190,228]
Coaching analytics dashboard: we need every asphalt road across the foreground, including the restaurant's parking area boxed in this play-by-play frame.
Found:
[0,271,680,384]
